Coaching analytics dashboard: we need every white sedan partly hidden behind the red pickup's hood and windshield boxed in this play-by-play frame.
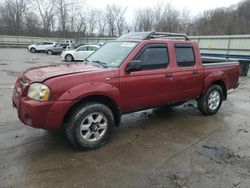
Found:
[61,45,100,62]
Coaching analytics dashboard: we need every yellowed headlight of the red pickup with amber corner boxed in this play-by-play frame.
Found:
[28,83,50,101]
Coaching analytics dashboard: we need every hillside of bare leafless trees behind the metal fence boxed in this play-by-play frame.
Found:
[0,0,250,38]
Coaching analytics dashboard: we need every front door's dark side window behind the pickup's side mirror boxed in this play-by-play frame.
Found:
[136,44,169,70]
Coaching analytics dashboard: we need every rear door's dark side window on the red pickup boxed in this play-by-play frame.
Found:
[175,44,195,67]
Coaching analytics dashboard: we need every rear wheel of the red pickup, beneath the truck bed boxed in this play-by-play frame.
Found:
[197,85,223,115]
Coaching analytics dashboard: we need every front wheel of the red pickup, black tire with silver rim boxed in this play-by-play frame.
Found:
[64,102,115,150]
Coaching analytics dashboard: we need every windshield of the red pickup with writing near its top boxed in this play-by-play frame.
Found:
[86,42,138,68]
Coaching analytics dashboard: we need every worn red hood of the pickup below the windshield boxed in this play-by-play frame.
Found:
[22,62,103,83]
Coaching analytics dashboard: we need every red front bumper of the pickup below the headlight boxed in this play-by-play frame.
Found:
[12,89,72,130]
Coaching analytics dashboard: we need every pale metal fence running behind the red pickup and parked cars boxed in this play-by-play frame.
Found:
[0,35,250,60]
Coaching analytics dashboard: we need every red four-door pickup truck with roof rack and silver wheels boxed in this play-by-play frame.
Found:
[12,32,240,149]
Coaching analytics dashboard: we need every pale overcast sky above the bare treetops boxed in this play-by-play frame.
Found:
[85,0,240,22]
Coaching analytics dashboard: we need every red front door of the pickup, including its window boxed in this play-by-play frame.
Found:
[120,44,176,112]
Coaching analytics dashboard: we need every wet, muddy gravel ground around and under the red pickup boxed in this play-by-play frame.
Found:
[0,49,250,188]
